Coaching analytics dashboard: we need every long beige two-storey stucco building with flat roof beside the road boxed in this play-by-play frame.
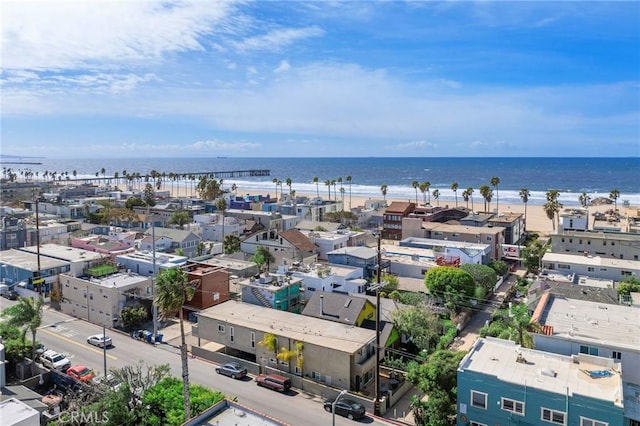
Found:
[197,301,375,391]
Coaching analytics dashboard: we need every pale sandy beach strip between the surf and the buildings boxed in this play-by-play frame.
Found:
[150,181,638,235]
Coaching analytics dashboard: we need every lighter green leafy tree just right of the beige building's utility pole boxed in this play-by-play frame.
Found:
[391,305,440,352]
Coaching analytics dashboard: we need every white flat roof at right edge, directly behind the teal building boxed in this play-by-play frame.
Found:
[539,296,640,352]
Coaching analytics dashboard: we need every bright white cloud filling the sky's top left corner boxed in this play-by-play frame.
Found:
[1,0,235,70]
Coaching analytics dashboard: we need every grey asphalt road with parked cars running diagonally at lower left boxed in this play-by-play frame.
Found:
[7,300,389,426]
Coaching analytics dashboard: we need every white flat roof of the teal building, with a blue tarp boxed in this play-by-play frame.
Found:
[458,338,623,406]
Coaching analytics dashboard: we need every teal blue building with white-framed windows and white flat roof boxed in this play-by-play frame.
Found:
[457,338,629,426]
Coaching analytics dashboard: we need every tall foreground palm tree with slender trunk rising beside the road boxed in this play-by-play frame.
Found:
[154,267,195,420]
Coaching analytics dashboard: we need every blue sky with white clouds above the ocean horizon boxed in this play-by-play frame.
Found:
[0,0,640,158]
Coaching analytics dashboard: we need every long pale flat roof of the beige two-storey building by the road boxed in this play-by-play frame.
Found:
[198,300,376,354]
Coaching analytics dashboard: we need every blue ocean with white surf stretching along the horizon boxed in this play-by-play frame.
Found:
[2,157,640,206]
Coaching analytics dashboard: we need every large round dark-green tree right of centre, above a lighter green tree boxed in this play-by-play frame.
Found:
[424,266,475,317]
